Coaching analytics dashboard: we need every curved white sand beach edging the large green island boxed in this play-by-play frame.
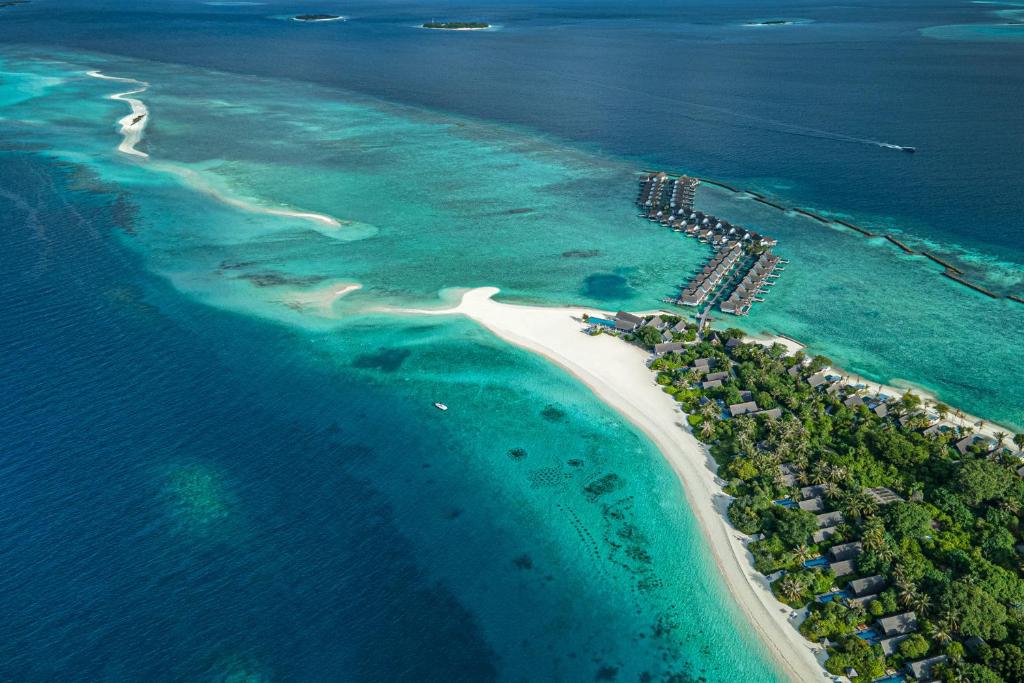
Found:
[395,288,823,681]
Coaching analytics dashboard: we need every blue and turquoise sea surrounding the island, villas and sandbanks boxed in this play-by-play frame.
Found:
[0,0,1024,682]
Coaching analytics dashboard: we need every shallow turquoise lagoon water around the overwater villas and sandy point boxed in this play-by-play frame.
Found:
[0,41,1024,681]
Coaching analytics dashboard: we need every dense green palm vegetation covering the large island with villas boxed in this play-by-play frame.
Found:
[630,328,1024,681]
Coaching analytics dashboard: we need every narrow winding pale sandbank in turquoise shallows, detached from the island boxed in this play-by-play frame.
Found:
[86,71,350,227]
